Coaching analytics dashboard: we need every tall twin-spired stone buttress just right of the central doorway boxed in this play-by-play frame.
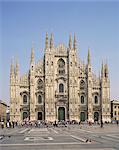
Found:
[68,35,79,120]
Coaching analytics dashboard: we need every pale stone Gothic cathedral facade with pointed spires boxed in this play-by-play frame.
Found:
[10,34,111,122]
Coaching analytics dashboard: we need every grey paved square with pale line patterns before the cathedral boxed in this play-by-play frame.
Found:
[0,125,119,150]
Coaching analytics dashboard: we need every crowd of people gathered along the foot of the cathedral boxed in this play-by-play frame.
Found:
[0,119,119,129]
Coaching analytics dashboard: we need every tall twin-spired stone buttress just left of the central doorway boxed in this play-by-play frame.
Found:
[44,33,56,121]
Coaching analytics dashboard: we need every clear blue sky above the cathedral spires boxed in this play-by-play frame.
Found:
[0,0,119,104]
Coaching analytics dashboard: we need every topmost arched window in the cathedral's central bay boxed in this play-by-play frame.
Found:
[58,58,65,75]
